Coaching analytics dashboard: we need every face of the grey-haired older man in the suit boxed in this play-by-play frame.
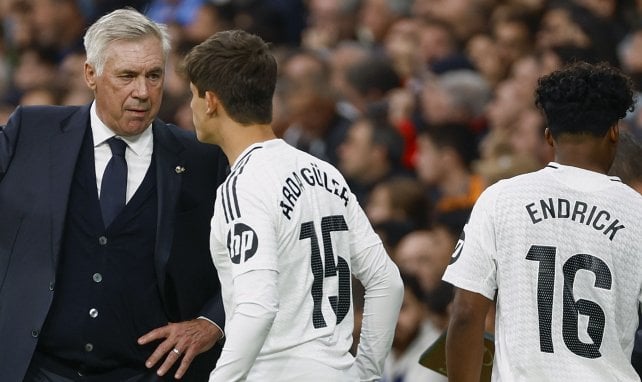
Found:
[85,37,165,136]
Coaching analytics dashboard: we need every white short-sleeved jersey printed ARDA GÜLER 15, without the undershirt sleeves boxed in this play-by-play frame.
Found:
[211,139,400,381]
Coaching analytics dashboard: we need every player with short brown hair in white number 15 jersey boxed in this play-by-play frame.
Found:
[185,31,403,382]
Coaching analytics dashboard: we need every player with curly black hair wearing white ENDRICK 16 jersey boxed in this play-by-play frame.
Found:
[443,63,642,382]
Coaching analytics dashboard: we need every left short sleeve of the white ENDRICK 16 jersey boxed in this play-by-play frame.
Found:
[443,186,498,300]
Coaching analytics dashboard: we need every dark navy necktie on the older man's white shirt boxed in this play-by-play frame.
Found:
[100,137,127,227]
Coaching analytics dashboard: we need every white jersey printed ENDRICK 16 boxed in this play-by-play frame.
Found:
[443,163,642,382]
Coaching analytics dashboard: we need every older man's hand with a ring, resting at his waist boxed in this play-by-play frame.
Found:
[138,318,223,379]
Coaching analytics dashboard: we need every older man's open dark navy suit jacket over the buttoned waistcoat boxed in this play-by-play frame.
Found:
[0,105,227,382]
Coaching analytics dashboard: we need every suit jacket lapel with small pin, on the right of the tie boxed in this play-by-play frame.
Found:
[152,120,184,300]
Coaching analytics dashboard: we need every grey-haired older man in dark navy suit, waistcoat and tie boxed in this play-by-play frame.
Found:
[0,9,227,382]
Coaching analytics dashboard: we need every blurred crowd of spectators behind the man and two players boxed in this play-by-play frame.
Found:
[0,0,642,382]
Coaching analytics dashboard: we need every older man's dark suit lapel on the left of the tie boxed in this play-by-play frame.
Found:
[47,105,90,263]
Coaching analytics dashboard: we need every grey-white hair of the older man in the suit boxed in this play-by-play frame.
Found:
[84,8,171,75]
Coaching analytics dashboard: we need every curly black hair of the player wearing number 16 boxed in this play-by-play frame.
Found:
[535,62,635,137]
